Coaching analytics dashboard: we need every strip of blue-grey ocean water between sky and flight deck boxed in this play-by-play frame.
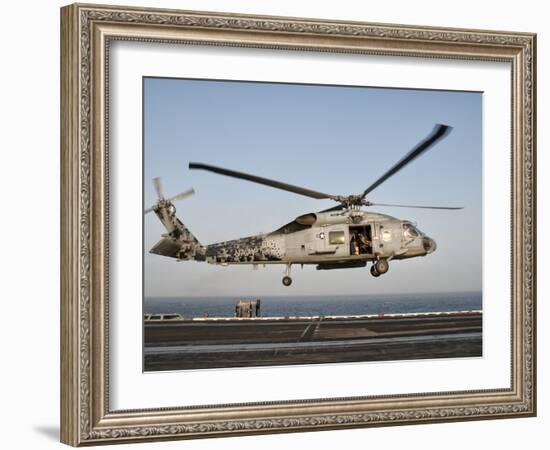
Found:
[143,292,482,318]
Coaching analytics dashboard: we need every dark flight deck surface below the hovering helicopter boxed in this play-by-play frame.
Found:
[144,311,482,371]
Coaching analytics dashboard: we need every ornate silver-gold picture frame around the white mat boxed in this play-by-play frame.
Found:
[61,4,536,446]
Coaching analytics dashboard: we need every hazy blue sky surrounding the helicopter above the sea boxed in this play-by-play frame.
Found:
[143,78,482,296]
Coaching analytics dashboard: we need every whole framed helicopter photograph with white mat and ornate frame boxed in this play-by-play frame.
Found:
[61,4,536,446]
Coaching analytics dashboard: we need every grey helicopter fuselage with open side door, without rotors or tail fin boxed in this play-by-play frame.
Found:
[197,210,436,269]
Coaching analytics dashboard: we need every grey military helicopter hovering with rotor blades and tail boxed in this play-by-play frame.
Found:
[144,124,463,286]
